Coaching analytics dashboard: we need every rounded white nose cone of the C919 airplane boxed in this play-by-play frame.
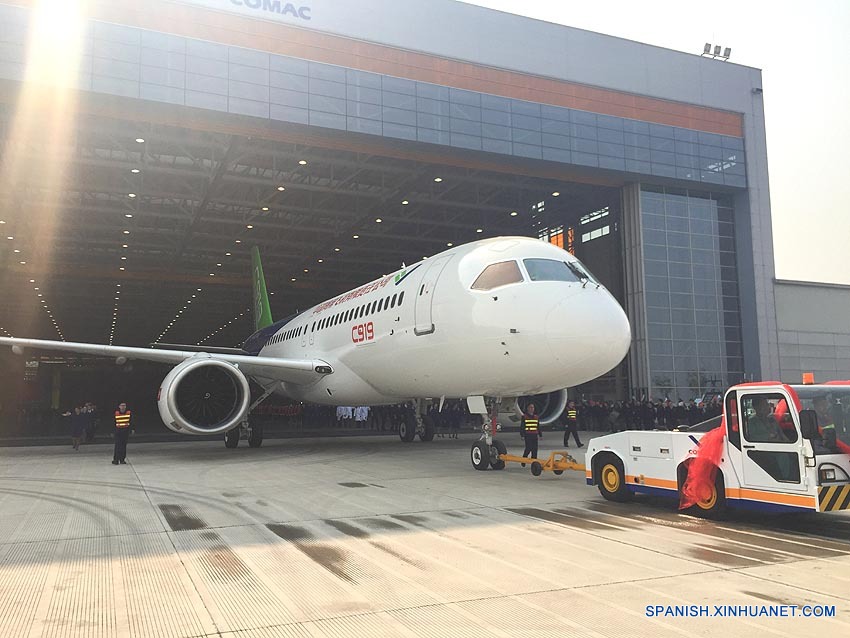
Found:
[546,288,631,383]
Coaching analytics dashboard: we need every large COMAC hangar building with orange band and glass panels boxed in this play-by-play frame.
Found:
[0,0,828,430]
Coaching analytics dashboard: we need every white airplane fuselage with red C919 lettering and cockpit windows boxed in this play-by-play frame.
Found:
[245,237,630,405]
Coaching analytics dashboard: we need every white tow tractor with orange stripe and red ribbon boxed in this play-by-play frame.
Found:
[585,381,850,515]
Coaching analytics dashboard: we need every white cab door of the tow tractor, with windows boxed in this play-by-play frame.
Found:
[738,392,807,492]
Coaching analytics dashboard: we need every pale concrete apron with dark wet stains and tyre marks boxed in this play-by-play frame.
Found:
[0,433,850,638]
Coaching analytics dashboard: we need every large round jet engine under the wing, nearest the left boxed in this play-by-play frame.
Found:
[157,354,251,434]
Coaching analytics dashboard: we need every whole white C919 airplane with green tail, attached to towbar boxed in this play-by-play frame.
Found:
[0,237,631,469]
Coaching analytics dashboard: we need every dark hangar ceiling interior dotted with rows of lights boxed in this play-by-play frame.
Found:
[0,104,624,346]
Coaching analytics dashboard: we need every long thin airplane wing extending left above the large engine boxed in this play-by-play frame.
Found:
[0,337,333,385]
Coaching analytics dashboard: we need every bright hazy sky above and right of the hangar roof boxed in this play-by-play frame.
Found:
[468,0,850,284]
